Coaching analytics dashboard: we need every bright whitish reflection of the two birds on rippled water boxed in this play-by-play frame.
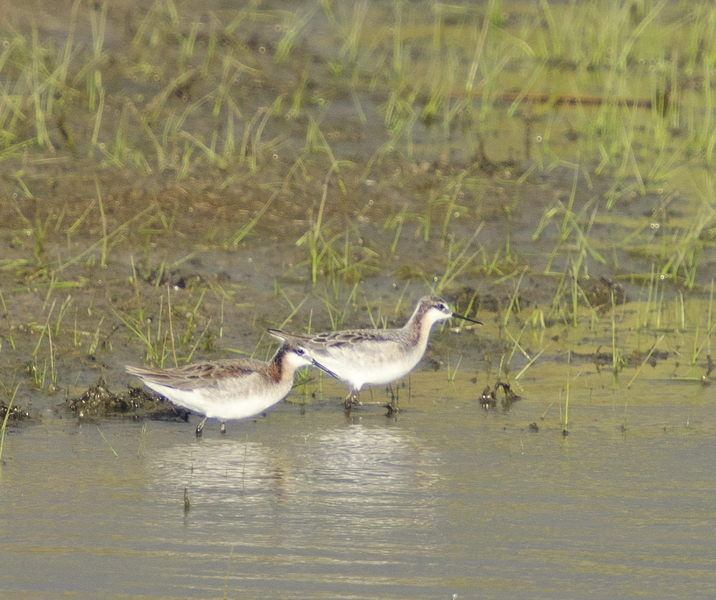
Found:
[148,424,438,546]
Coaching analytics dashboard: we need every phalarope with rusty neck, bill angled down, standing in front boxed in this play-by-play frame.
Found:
[126,343,336,436]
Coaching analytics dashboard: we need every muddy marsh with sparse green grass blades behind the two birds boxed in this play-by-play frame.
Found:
[0,0,716,429]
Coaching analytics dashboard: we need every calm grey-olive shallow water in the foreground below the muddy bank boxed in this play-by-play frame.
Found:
[0,373,716,599]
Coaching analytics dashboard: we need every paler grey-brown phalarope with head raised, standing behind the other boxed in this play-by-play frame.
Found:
[268,296,482,410]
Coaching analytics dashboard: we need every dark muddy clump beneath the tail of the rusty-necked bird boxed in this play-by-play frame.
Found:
[65,376,191,421]
